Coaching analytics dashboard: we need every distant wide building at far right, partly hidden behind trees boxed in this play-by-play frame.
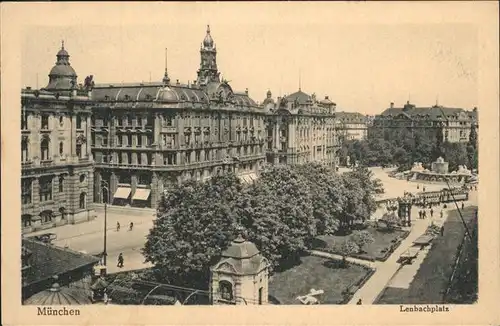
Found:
[369,102,478,143]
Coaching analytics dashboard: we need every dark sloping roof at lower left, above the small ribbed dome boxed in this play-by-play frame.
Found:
[22,239,99,285]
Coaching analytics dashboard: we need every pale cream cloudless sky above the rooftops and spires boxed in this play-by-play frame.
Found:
[21,3,478,114]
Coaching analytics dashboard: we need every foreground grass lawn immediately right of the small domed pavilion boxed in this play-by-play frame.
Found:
[269,256,371,304]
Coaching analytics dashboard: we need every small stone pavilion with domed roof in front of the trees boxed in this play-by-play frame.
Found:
[210,235,269,305]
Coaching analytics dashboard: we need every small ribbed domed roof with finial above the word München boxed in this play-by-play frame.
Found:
[23,277,92,306]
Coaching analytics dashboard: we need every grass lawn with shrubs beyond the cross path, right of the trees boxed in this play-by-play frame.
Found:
[314,226,406,260]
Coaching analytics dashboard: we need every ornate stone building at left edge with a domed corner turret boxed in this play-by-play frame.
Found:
[21,43,93,232]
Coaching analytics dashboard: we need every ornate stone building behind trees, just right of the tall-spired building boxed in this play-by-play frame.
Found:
[262,89,339,166]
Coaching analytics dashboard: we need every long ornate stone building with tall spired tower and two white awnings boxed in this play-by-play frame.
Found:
[92,28,266,207]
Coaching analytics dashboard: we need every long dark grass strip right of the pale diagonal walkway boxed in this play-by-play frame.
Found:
[377,207,477,304]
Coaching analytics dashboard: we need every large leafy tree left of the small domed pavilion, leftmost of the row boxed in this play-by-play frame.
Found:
[142,175,243,285]
